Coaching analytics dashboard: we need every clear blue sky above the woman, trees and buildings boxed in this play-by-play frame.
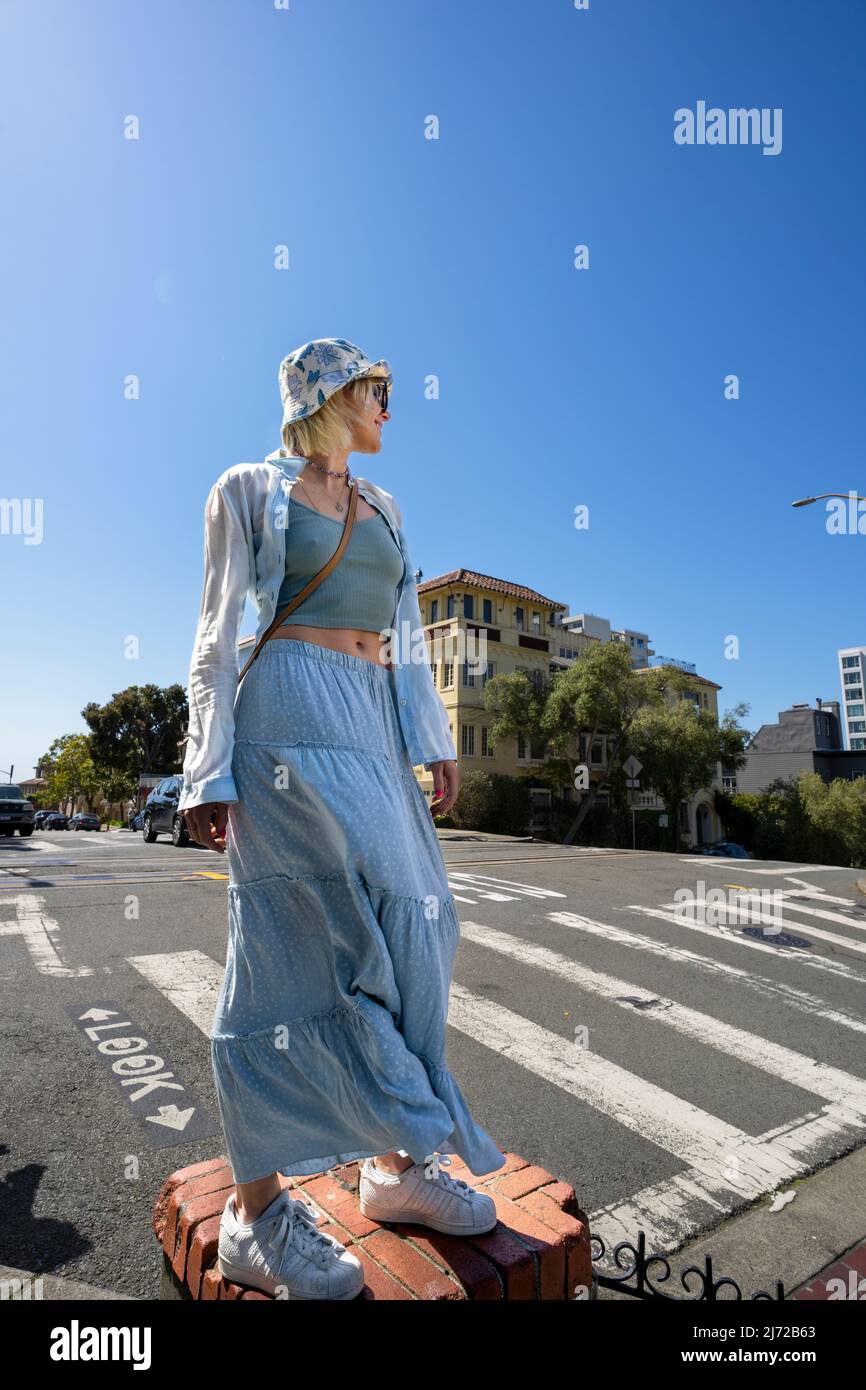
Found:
[0,0,866,776]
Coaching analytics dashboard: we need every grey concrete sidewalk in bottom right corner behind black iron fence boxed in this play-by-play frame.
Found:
[599,1147,866,1302]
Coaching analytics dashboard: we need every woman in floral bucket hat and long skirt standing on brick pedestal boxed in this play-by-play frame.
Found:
[179,338,505,1298]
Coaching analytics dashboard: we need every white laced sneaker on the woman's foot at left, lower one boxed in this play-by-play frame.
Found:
[217,1187,364,1300]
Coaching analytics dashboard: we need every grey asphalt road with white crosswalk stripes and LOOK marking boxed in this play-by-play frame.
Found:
[0,831,866,1298]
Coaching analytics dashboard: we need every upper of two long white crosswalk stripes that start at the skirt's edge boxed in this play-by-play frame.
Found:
[460,913,866,1123]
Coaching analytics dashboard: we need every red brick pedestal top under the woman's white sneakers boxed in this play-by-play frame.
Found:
[153,1154,592,1302]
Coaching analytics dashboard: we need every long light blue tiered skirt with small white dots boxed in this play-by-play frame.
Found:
[211,638,505,1183]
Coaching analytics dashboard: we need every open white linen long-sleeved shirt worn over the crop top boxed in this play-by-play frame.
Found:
[178,449,457,810]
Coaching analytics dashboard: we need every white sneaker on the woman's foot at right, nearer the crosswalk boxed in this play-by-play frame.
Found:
[359,1154,496,1236]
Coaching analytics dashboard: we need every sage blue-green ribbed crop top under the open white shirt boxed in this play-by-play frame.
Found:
[277,495,403,632]
